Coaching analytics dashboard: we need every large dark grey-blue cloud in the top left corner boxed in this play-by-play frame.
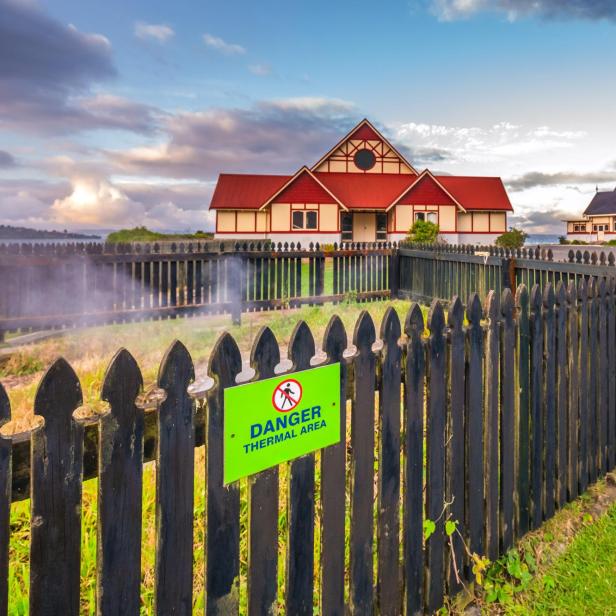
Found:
[0,0,164,135]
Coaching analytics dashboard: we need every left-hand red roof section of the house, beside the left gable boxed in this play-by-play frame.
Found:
[210,173,293,210]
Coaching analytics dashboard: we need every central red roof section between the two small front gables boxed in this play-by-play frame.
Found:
[315,172,417,210]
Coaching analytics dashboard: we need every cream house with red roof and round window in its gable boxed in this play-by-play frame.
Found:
[210,120,513,244]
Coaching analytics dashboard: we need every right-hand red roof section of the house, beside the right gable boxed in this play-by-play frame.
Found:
[436,175,513,212]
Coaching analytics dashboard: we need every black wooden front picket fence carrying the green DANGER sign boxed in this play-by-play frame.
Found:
[0,278,616,616]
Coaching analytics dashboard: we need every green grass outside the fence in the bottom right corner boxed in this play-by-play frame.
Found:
[510,505,616,616]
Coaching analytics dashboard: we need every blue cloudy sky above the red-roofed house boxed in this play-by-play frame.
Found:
[0,0,616,233]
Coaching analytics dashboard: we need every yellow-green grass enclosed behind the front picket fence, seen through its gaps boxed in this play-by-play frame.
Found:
[0,301,410,615]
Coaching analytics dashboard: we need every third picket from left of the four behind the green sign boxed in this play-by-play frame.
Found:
[286,321,315,615]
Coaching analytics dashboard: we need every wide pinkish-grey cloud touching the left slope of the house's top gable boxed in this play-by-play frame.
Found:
[107,98,358,180]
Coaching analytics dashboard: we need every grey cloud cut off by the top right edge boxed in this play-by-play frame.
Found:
[430,0,616,21]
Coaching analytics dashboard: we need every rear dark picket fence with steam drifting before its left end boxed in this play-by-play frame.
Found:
[0,242,395,334]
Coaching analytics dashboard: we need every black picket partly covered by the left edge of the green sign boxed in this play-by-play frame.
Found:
[205,332,242,616]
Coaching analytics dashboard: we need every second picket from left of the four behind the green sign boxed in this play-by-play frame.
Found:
[248,327,280,615]
